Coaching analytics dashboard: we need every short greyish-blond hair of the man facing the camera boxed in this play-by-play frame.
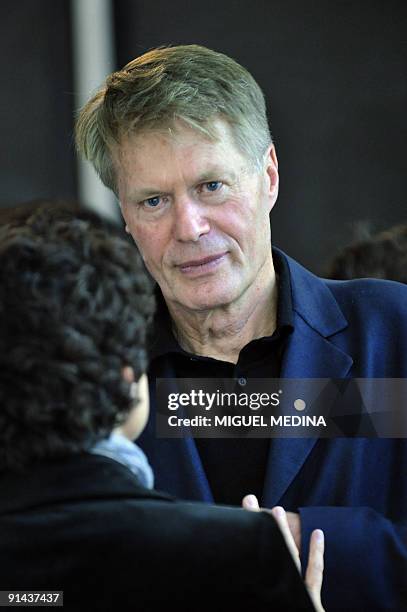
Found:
[76,45,271,193]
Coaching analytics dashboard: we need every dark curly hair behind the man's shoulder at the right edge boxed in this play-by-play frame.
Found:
[325,224,407,283]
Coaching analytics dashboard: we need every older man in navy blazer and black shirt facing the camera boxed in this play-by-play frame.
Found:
[77,45,407,610]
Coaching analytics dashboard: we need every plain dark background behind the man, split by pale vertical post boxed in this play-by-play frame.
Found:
[0,0,407,272]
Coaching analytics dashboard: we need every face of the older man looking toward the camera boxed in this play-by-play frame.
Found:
[114,120,278,310]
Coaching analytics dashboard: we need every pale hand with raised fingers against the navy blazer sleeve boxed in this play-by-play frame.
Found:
[242,495,324,612]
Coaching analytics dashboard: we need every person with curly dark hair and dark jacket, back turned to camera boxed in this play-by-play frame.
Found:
[0,208,323,611]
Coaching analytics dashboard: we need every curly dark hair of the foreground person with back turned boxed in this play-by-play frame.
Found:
[0,208,155,470]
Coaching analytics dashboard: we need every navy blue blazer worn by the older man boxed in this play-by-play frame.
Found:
[139,251,407,611]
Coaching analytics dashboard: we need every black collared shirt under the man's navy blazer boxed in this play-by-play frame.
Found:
[149,251,294,505]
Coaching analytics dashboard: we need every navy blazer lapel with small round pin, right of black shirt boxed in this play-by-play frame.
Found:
[261,252,353,507]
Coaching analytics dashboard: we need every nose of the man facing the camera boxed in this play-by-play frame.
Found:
[173,198,210,242]
